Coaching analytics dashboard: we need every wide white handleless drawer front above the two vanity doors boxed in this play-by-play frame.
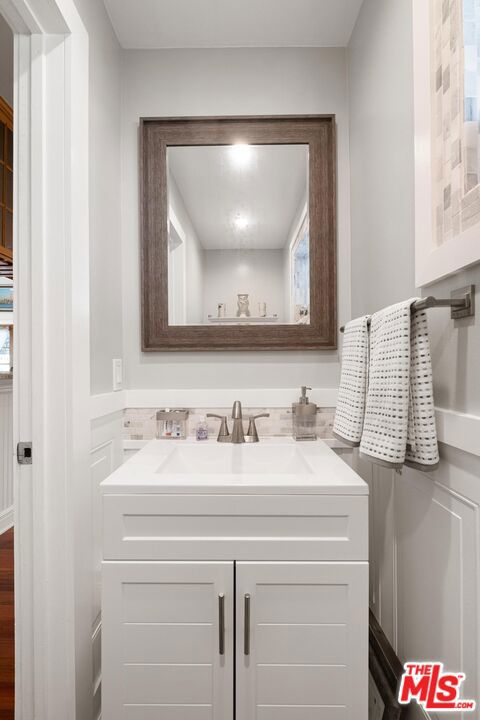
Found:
[103,495,368,561]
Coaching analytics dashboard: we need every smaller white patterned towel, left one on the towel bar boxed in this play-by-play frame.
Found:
[333,315,368,446]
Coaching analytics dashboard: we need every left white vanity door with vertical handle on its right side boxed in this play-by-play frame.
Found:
[102,562,234,720]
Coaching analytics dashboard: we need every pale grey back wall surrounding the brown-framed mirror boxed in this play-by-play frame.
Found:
[122,48,350,389]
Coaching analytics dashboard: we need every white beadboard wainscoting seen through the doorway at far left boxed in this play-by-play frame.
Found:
[0,383,13,534]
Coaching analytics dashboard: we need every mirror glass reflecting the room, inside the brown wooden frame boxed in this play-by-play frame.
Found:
[167,144,310,325]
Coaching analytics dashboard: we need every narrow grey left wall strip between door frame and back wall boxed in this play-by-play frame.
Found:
[75,0,123,394]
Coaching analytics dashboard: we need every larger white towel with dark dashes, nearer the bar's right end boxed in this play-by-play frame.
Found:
[360,298,439,470]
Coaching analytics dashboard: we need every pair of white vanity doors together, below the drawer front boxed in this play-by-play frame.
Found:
[102,561,368,720]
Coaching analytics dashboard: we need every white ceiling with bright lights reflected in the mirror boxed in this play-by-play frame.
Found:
[167,145,308,250]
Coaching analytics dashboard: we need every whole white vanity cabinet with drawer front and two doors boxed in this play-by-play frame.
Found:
[102,438,368,720]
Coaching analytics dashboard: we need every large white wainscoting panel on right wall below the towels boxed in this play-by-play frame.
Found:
[396,469,480,715]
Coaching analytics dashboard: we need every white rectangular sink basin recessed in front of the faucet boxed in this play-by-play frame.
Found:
[157,444,313,475]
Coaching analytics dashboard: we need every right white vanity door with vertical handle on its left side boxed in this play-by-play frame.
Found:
[236,562,368,720]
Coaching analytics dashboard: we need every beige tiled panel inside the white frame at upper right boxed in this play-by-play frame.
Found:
[431,0,480,245]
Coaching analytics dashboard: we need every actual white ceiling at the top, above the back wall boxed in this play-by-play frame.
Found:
[104,0,363,49]
